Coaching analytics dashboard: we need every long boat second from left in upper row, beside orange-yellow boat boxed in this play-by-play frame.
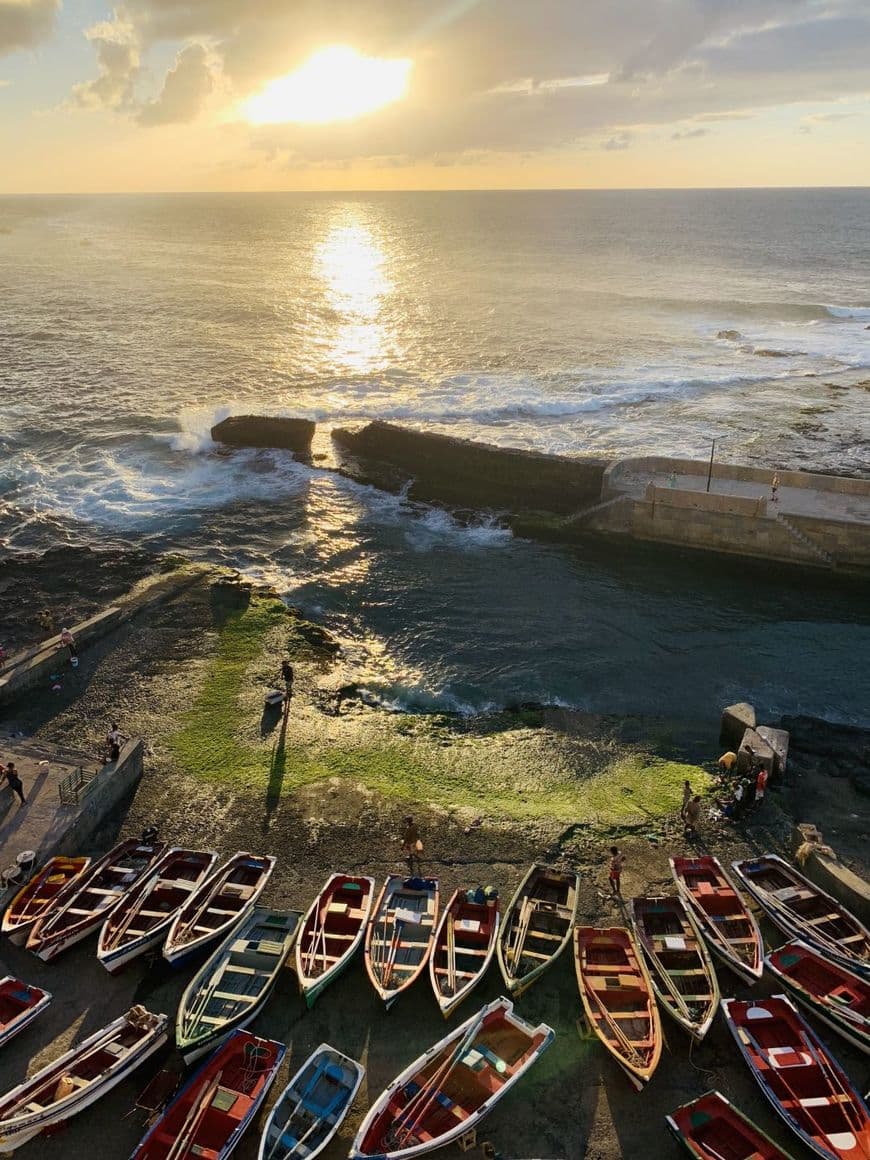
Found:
[27,838,165,962]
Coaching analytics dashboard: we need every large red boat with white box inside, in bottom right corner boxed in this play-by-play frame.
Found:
[722,995,870,1160]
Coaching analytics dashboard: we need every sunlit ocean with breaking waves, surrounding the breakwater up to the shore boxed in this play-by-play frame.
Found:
[0,189,870,724]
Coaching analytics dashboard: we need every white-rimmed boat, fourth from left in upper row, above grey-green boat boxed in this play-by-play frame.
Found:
[164,850,277,966]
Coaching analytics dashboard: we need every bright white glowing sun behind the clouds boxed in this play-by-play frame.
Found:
[244,44,413,125]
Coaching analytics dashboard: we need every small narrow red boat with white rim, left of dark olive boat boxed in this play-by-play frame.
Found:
[429,890,500,1018]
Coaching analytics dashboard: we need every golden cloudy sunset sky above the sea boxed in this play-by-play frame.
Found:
[0,0,870,194]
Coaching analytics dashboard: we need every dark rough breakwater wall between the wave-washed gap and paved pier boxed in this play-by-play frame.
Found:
[332,422,608,514]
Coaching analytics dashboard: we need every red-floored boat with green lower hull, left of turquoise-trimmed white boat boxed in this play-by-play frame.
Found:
[296,873,375,1007]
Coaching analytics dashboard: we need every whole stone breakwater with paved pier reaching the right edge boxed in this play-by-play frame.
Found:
[212,416,870,573]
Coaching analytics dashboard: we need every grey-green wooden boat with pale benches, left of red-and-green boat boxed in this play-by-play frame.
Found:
[175,906,302,1064]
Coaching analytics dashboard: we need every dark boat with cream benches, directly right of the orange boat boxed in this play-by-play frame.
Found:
[631,896,719,1043]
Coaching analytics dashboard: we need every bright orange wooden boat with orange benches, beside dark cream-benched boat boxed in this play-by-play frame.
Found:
[574,927,661,1090]
